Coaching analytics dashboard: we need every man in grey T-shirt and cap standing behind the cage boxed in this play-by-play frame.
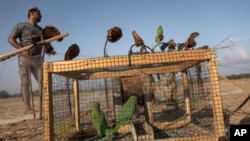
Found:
[8,7,55,113]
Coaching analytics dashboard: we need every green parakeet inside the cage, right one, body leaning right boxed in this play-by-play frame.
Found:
[103,96,138,140]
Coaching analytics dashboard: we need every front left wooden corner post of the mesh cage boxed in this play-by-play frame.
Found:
[43,63,54,141]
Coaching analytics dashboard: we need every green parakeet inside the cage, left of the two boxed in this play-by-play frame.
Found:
[91,102,108,136]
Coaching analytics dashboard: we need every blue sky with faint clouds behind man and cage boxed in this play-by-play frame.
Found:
[0,0,250,94]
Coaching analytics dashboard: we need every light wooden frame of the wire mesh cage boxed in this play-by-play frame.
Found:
[43,49,225,141]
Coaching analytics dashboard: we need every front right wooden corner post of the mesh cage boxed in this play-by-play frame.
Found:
[208,50,225,138]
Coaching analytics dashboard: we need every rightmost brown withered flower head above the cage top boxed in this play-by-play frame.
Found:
[178,32,199,50]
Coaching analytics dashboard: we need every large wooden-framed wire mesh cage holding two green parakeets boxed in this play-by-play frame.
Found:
[43,49,225,141]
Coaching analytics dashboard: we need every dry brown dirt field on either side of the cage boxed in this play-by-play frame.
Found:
[0,79,250,141]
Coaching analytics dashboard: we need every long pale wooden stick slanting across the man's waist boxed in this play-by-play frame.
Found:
[0,33,69,61]
